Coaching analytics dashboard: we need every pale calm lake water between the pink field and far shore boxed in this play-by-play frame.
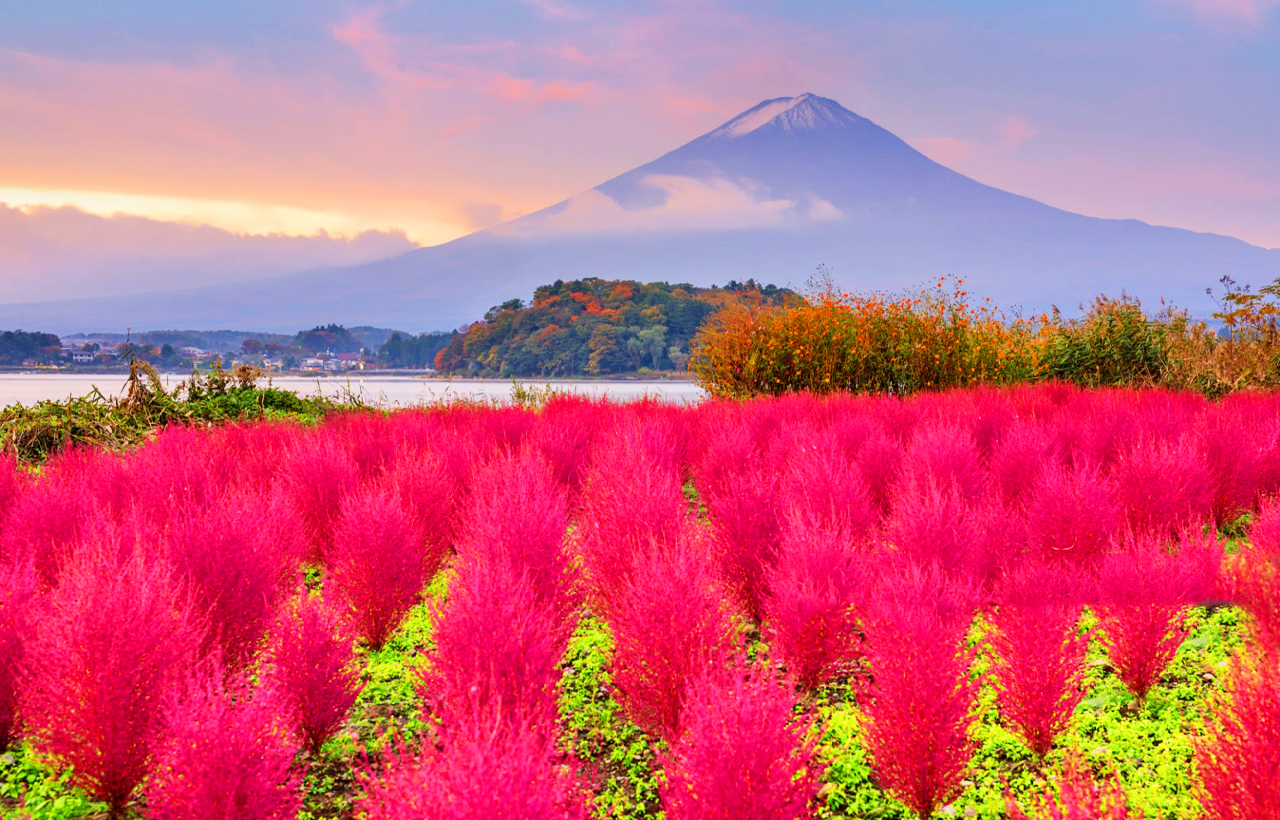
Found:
[0,374,705,407]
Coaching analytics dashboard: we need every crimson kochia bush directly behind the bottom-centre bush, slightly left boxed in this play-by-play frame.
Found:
[609,544,740,738]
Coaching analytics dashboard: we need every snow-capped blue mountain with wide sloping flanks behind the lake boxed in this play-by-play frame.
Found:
[0,93,1280,331]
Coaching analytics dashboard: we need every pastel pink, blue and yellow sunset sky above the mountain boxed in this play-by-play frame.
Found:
[0,0,1280,301]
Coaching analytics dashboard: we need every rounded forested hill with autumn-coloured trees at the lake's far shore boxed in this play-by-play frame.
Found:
[435,278,797,379]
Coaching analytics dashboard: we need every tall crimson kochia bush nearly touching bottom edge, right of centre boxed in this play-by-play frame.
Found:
[863,564,979,819]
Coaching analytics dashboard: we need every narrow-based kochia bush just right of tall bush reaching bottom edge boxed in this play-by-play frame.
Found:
[991,559,1089,757]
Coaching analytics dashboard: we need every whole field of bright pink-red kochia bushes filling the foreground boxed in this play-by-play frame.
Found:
[0,385,1280,820]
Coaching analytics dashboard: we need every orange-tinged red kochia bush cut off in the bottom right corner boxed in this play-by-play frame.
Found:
[1196,655,1280,820]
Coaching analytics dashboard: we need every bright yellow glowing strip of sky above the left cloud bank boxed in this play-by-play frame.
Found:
[0,185,471,246]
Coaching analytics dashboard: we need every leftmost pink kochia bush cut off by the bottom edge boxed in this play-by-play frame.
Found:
[146,668,302,820]
